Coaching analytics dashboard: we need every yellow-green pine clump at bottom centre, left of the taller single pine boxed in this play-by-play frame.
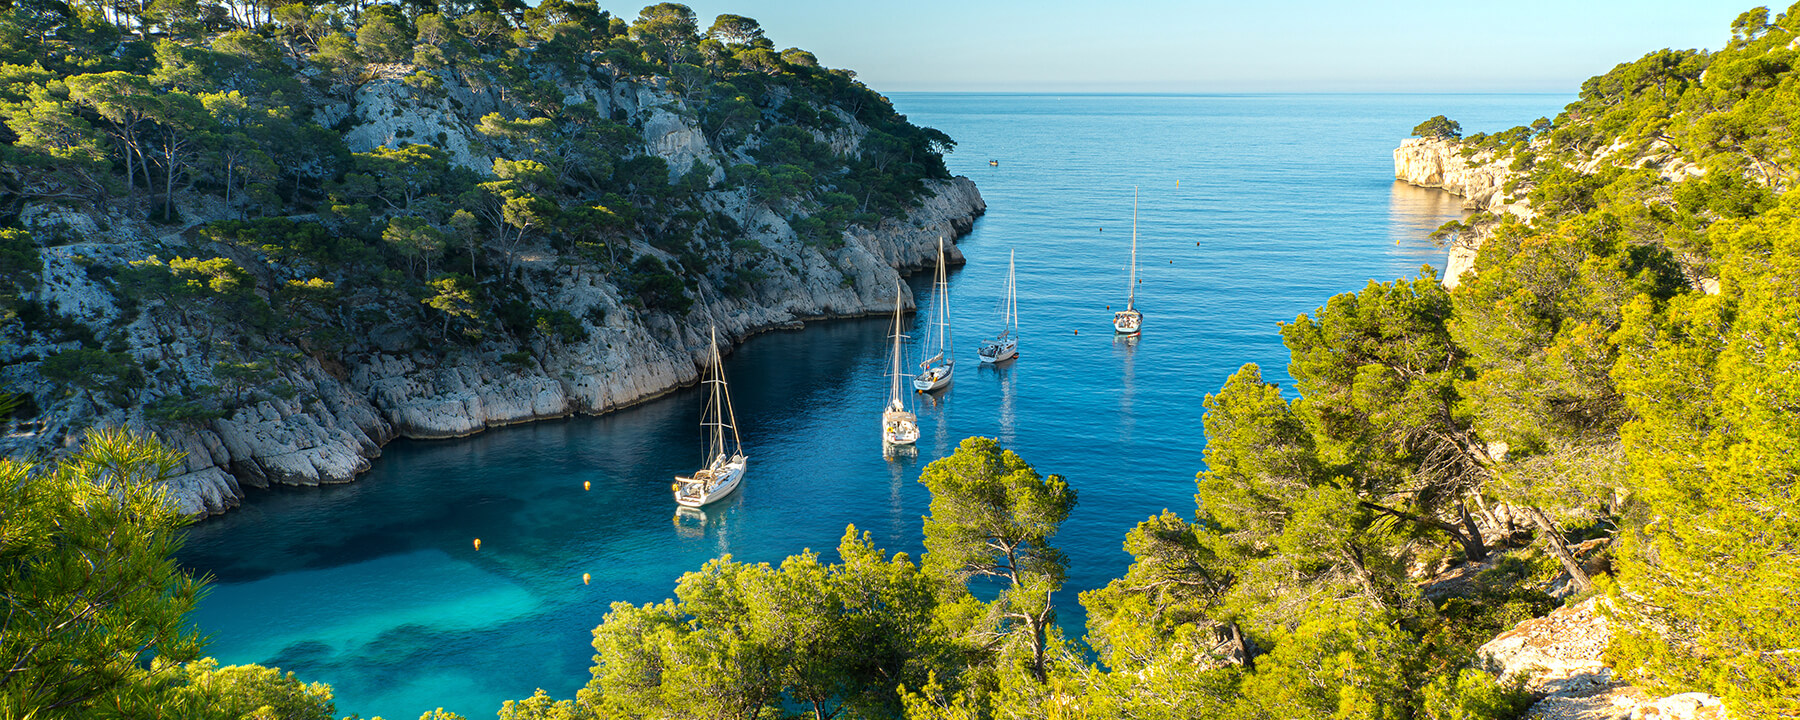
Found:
[594,527,947,718]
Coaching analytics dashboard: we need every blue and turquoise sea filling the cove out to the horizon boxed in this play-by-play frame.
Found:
[182,94,1570,720]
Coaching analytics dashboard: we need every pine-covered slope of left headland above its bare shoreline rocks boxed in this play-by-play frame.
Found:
[0,0,954,468]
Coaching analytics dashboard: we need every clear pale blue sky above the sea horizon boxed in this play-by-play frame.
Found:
[673,0,1756,92]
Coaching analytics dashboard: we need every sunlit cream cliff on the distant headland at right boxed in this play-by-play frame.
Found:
[1393,137,1532,288]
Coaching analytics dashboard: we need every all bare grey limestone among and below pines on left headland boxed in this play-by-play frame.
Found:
[0,74,986,513]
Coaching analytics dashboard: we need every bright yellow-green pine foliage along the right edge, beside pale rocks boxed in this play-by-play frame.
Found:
[1615,188,1800,718]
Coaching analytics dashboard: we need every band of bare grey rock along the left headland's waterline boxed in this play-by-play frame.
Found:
[164,178,986,515]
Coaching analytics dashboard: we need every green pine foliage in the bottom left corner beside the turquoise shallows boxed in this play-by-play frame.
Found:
[0,430,202,720]
